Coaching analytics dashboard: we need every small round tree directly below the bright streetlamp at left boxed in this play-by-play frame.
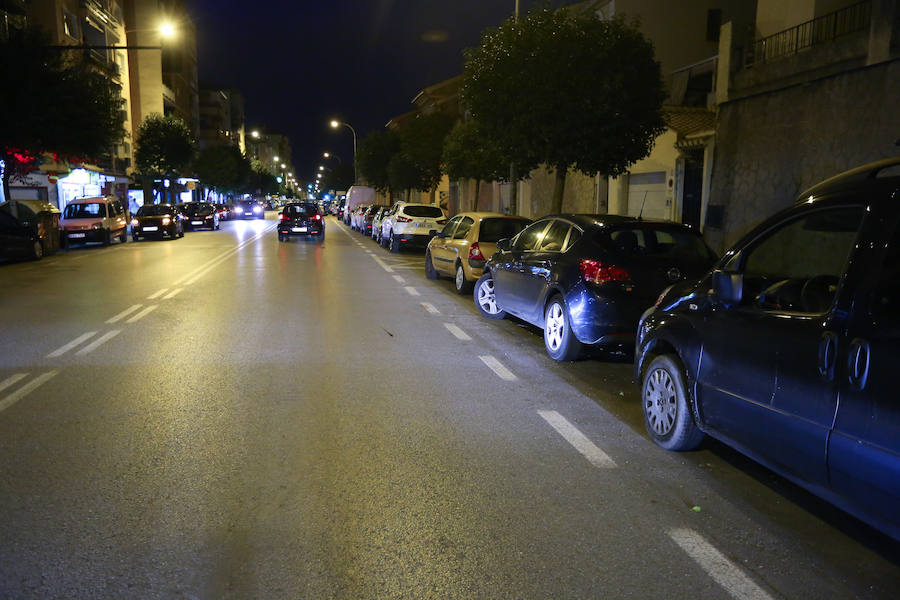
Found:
[134,113,194,202]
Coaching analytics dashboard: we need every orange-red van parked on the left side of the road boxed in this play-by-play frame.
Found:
[59,196,128,246]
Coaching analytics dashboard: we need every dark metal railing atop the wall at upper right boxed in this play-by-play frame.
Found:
[744,0,872,68]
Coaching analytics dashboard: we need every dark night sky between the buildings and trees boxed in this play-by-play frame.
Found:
[187,0,567,185]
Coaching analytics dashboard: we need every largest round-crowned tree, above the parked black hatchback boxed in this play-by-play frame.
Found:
[462,8,665,212]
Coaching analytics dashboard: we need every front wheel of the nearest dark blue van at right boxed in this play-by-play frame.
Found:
[641,354,705,451]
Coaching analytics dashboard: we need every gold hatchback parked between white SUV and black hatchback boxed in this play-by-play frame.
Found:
[425,212,531,294]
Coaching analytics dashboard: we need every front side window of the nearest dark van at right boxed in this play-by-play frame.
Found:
[741,206,864,314]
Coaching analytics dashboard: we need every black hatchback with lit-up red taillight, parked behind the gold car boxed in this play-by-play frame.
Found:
[474,215,716,360]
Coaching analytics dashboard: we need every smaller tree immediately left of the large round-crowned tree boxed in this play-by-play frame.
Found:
[443,119,509,210]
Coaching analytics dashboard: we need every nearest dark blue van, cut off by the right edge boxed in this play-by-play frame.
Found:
[635,158,900,540]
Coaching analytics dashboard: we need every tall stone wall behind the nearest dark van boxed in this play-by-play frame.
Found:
[704,59,900,251]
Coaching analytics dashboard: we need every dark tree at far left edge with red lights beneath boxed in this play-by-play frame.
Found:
[0,29,124,200]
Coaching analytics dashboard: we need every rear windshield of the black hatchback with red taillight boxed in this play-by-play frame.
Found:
[599,225,715,260]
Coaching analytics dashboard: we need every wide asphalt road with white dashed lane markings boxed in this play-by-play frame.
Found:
[0,213,900,600]
